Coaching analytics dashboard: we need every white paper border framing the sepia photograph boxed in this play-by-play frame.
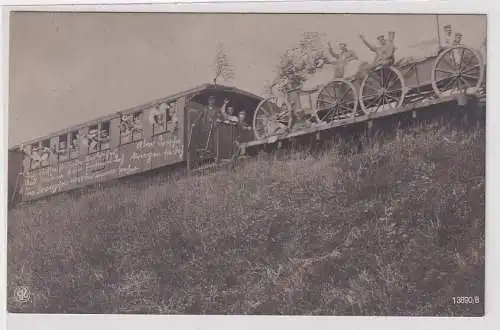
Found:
[0,0,500,330]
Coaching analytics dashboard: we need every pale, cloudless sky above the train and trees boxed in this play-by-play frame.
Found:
[8,12,486,146]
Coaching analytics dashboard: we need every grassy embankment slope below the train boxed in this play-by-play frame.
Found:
[8,120,485,316]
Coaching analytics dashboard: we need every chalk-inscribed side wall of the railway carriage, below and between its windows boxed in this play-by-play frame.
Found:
[20,98,185,200]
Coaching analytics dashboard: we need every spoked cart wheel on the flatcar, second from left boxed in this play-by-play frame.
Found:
[316,79,358,123]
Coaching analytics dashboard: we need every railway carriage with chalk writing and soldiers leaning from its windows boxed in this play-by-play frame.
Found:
[8,84,262,202]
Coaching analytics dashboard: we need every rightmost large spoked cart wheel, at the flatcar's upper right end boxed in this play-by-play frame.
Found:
[431,46,484,97]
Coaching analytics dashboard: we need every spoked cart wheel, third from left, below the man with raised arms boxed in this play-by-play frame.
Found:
[359,66,406,114]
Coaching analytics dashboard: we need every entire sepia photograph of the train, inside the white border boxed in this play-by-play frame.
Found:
[5,10,486,317]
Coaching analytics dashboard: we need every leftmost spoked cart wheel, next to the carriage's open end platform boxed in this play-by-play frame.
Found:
[253,98,292,140]
